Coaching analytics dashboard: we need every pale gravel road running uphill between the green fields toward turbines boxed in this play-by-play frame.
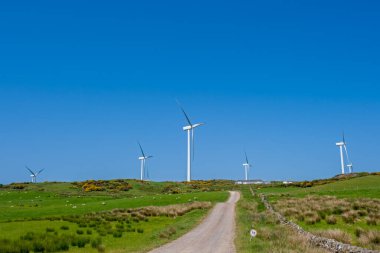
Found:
[149,192,240,253]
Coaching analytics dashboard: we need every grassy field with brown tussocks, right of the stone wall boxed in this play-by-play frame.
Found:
[249,173,380,250]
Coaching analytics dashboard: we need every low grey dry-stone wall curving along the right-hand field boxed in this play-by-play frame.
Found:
[251,192,380,253]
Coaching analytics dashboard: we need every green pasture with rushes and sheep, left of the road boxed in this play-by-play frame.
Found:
[0,180,233,253]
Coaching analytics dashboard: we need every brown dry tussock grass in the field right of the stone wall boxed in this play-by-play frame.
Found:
[274,196,380,250]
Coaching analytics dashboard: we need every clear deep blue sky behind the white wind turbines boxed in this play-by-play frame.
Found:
[0,0,380,183]
